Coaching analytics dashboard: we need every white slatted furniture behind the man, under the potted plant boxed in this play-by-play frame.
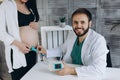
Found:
[41,25,72,49]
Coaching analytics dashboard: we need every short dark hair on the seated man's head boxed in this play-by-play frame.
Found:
[71,8,92,21]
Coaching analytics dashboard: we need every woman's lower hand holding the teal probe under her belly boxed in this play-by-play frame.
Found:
[12,40,30,53]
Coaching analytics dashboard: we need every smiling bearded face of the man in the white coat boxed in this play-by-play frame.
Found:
[72,13,91,37]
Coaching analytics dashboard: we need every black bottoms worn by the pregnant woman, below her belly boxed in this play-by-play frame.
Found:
[11,50,37,80]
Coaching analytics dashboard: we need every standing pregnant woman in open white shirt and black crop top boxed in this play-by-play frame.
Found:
[0,0,39,80]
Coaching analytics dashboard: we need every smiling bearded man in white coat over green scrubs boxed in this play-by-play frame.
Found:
[40,8,108,77]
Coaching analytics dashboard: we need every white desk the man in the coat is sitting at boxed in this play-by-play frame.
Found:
[21,62,120,80]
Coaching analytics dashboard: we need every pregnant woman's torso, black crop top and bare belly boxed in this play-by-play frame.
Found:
[18,4,38,47]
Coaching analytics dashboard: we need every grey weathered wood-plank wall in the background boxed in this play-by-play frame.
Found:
[0,0,120,80]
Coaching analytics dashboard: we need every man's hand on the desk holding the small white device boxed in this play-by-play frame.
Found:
[55,62,76,76]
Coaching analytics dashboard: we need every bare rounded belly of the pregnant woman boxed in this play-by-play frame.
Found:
[20,26,38,47]
